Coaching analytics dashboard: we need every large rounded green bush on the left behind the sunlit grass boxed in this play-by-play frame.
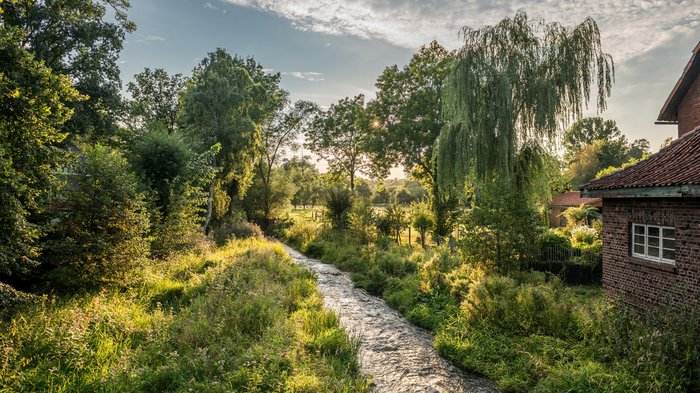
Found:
[43,145,149,286]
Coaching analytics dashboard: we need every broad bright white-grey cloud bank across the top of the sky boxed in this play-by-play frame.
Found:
[223,0,700,61]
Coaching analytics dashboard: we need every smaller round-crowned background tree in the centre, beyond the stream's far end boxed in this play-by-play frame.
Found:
[306,94,374,191]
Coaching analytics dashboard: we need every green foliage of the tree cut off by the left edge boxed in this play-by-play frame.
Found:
[0,25,81,276]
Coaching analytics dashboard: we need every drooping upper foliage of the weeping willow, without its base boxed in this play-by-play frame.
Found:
[436,12,614,191]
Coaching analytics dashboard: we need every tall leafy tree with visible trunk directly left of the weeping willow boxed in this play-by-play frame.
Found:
[369,41,455,241]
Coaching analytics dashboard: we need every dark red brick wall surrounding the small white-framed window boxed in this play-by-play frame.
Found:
[603,198,700,307]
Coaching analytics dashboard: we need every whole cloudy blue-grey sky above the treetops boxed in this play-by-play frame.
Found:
[120,0,700,175]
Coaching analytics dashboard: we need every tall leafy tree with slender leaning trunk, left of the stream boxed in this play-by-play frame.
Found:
[180,48,284,230]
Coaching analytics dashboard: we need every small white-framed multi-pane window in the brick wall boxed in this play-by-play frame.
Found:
[632,224,676,264]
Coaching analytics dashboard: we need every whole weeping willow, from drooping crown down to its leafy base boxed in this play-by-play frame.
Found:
[436,12,614,271]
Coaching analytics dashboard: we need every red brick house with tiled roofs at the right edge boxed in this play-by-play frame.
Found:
[581,44,700,307]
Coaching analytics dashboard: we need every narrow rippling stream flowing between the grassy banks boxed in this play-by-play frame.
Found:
[285,246,497,393]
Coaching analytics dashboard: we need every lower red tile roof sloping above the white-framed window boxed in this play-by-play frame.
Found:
[581,127,700,191]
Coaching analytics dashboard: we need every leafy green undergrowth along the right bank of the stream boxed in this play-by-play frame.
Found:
[280,222,700,393]
